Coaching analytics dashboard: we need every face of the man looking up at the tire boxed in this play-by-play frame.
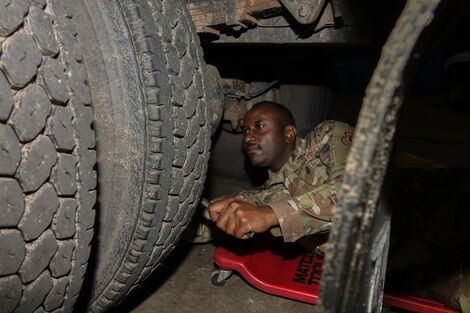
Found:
[244,106,289,171]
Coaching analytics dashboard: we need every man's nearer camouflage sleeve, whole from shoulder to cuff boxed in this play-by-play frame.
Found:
[268,122,353,242]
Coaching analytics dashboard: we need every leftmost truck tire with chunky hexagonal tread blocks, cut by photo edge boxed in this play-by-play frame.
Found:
[0,0,96,313]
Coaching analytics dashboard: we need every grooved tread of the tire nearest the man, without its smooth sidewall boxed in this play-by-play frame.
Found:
[90,0,211,312]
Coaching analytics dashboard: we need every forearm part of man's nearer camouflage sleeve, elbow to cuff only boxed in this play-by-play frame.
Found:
[268,177,342,242]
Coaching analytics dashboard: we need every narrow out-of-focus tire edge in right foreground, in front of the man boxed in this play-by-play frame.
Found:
[317,0,444,313]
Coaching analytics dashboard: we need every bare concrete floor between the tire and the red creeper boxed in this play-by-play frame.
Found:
[117,242,324,313]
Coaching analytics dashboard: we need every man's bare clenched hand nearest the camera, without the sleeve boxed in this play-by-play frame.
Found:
[208,198,279,239]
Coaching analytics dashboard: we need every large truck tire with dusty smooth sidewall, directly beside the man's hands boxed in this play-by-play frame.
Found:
[66,0,211,312]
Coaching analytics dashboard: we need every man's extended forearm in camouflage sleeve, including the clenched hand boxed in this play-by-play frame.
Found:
[208,177,342,242]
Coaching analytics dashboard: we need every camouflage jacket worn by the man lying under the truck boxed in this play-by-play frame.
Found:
[234,121,353,242]
